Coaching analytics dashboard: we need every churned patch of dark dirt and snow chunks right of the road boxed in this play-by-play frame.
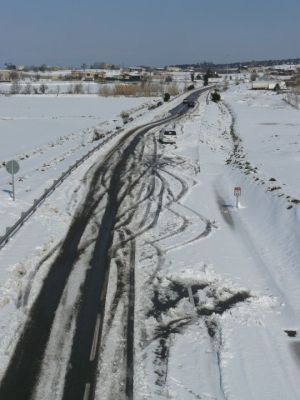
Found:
[147,277,251,386]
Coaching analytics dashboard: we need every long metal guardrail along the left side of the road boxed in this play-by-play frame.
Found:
[0,130,120,249]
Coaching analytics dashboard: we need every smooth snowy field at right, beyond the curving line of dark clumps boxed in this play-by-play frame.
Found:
[224,85,300,204]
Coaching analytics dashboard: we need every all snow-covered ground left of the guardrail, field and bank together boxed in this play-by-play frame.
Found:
[0,95,161,236]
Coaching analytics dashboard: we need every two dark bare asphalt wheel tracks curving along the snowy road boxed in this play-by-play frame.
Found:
[0,88,208,400]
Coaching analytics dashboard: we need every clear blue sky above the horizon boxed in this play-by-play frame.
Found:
[0,0,300,66]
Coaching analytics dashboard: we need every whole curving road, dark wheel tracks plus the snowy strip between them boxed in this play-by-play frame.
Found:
[0,86,206,400]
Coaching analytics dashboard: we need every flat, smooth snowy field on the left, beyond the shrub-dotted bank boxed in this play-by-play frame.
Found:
[0,95,151,160]
